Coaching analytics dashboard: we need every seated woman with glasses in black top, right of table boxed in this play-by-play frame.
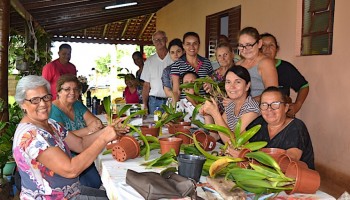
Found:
[248,87,315,169]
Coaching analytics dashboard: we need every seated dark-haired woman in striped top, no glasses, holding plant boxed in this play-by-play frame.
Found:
[200,65,260,142]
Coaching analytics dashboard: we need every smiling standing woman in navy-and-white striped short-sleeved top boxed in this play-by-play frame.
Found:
[170,32,213,102]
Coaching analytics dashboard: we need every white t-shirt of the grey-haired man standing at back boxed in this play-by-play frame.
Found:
[141,52,173,98]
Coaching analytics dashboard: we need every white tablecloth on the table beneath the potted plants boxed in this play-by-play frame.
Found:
[96,150,335,200]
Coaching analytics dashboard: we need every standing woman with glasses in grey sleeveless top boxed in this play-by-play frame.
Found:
[236,27,278,101]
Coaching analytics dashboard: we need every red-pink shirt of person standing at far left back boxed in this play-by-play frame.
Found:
[42,59,77,99]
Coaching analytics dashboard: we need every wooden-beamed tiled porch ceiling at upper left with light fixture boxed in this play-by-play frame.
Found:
[10,0,173,45]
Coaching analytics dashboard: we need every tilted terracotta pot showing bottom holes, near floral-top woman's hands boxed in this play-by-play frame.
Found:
[112,135,140,162]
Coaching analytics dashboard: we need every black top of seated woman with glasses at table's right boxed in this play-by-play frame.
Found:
[247,116,315,169]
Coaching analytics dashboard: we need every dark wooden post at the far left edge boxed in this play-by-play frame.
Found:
[0,0,10,121]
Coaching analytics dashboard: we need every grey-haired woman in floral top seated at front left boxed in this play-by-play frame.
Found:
[13,75,128,199]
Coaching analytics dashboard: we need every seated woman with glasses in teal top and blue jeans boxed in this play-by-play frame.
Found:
[50,74,103,188]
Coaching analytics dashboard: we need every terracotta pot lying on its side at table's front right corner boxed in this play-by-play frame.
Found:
[286,161,321,194]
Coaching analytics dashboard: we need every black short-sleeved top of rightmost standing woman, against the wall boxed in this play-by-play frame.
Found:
[276,60,309,96]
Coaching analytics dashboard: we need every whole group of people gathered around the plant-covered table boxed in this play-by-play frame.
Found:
[13,27,314,199]
